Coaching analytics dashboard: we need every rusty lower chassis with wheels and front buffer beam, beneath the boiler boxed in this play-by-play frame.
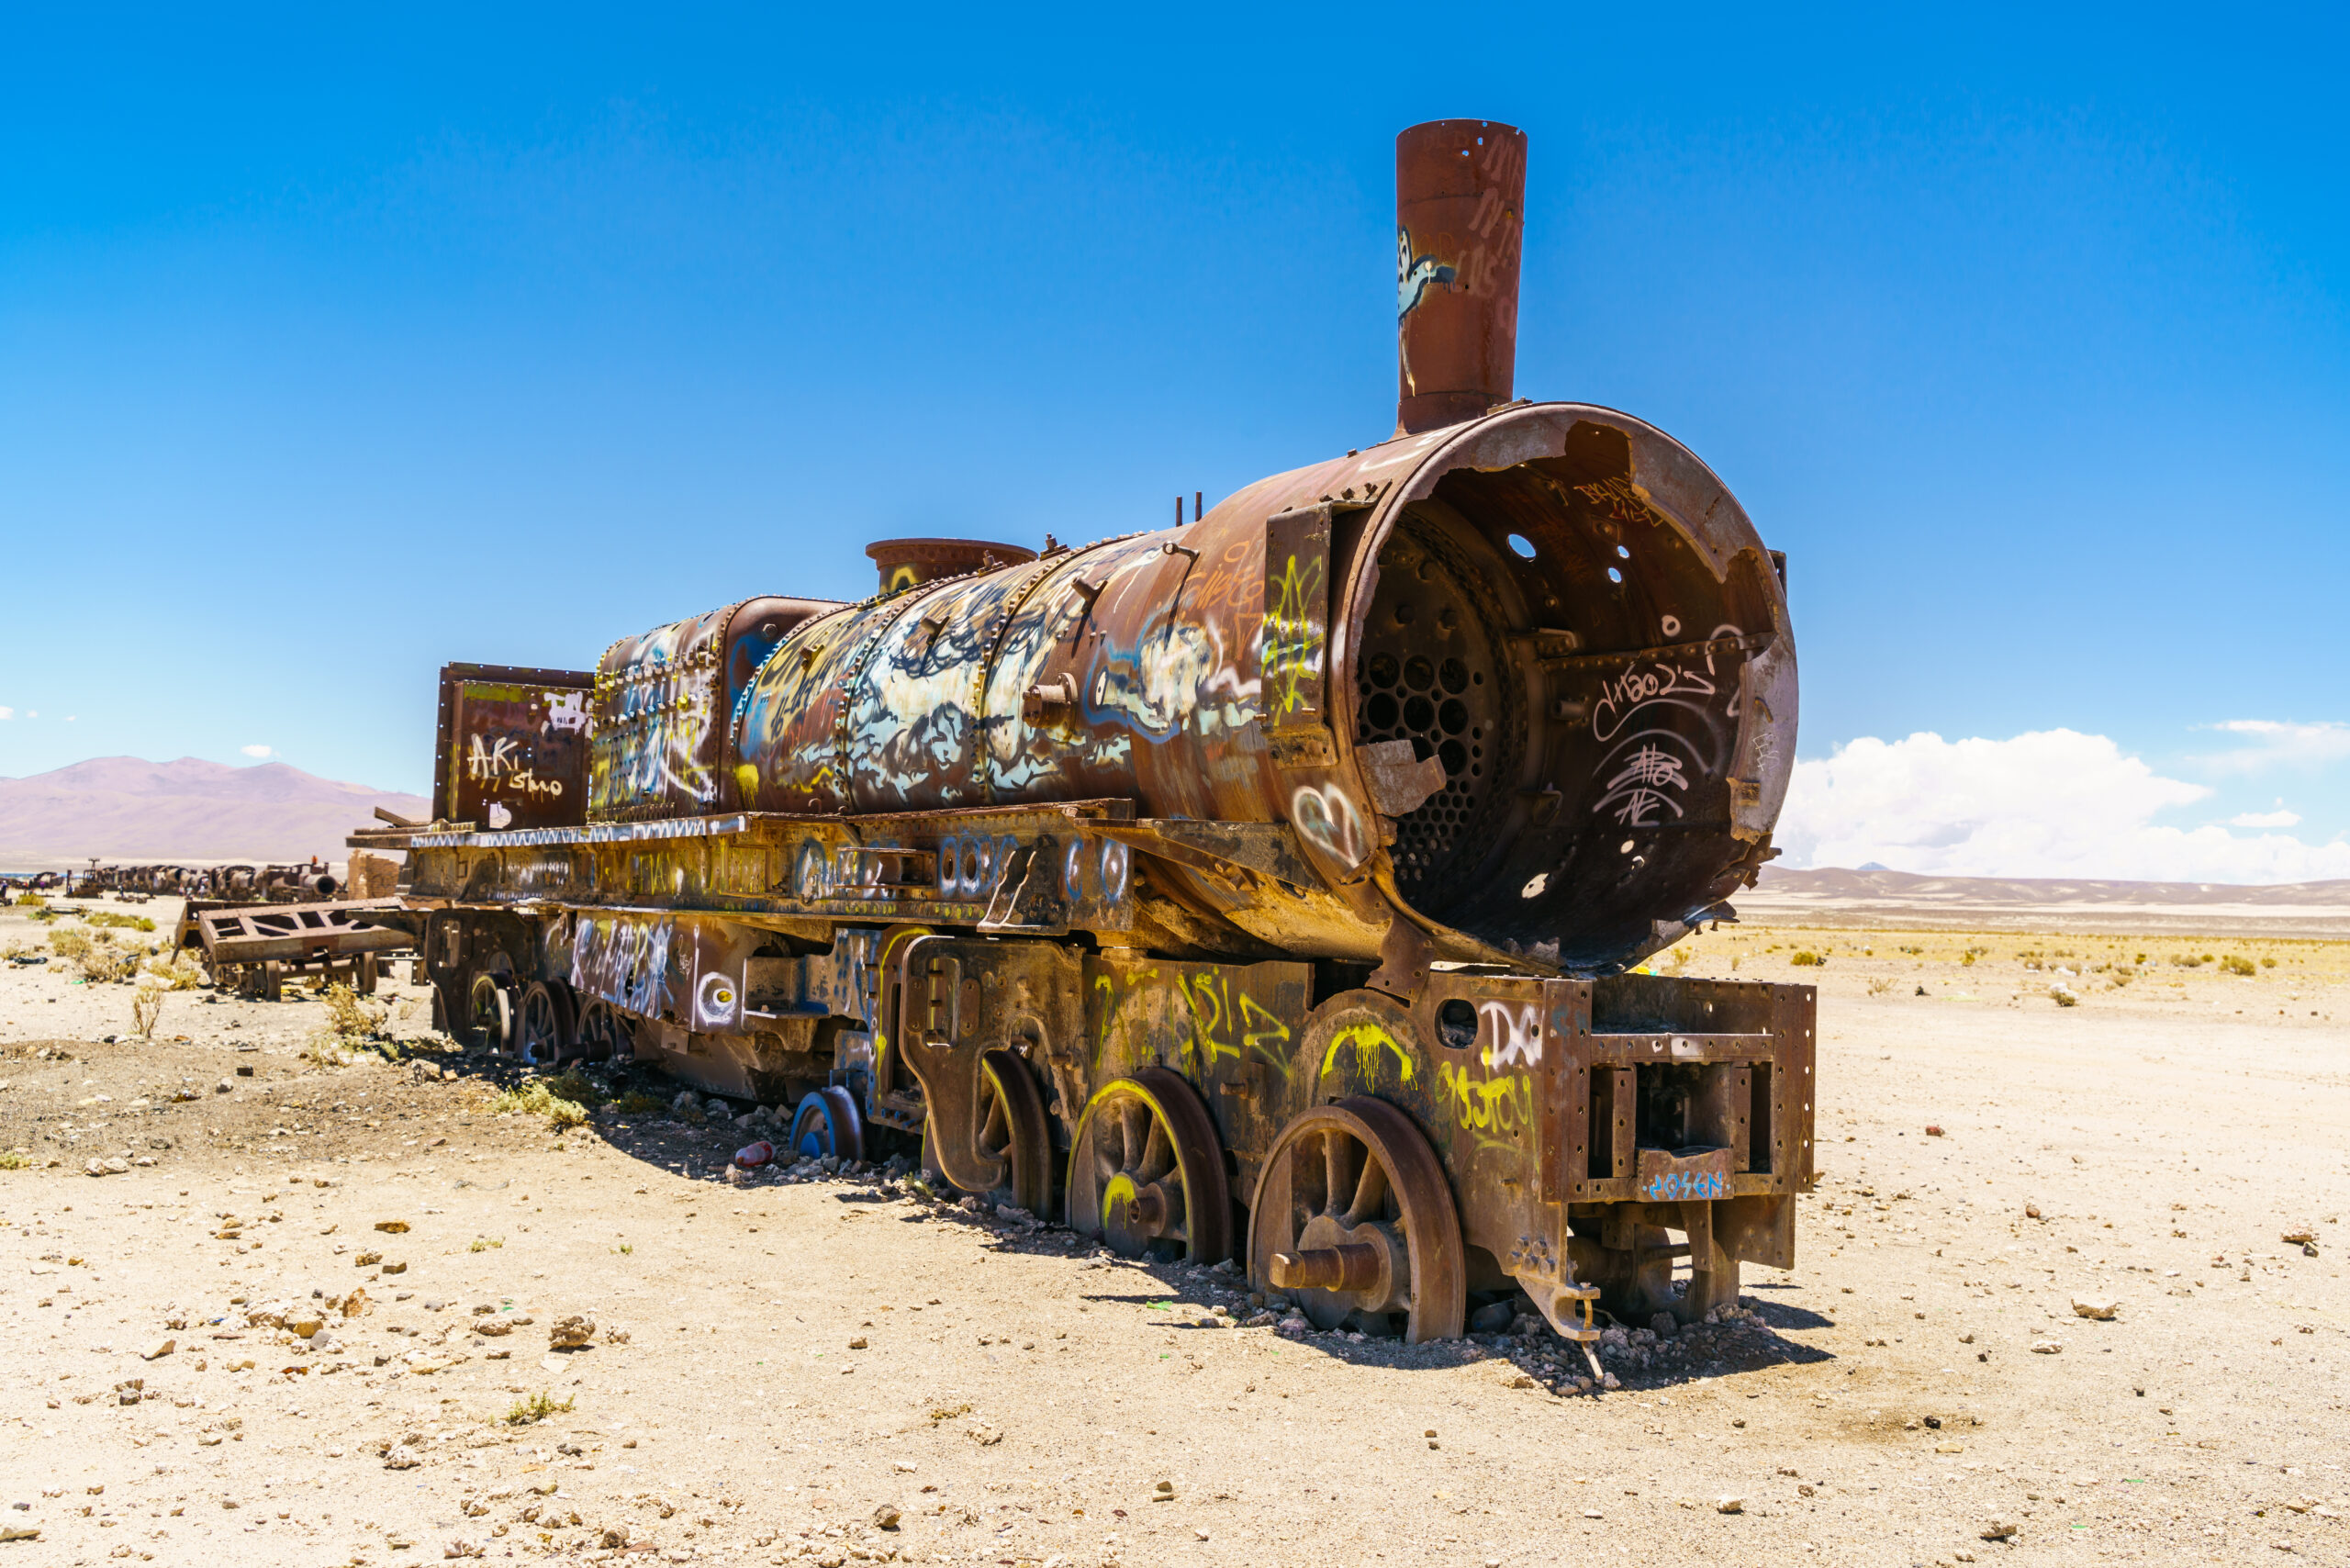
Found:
[366,818,1814,1340]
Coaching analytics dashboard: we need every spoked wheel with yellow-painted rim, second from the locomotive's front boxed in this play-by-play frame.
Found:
[1069,1068,1231,1262]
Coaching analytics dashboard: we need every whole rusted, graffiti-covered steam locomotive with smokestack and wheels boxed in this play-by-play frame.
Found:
[352,120,1814,1340]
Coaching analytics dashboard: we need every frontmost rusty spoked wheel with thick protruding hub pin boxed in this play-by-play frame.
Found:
[1248,1095,1469,1345]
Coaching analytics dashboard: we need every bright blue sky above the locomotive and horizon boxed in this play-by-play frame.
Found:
[0,7,2350,879]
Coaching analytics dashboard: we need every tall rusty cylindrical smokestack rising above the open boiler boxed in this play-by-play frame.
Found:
[1396,120,1525,435]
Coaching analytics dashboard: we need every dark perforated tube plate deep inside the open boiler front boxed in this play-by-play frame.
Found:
[1356,515,1516,910]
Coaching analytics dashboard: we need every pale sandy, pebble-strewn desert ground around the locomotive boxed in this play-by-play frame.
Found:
[0,901,2350,1568]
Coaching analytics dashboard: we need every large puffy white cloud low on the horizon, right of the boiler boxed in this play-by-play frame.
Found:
[1774,729,2350,884]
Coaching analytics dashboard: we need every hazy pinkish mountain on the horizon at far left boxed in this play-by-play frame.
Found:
[0,757,430,872]
